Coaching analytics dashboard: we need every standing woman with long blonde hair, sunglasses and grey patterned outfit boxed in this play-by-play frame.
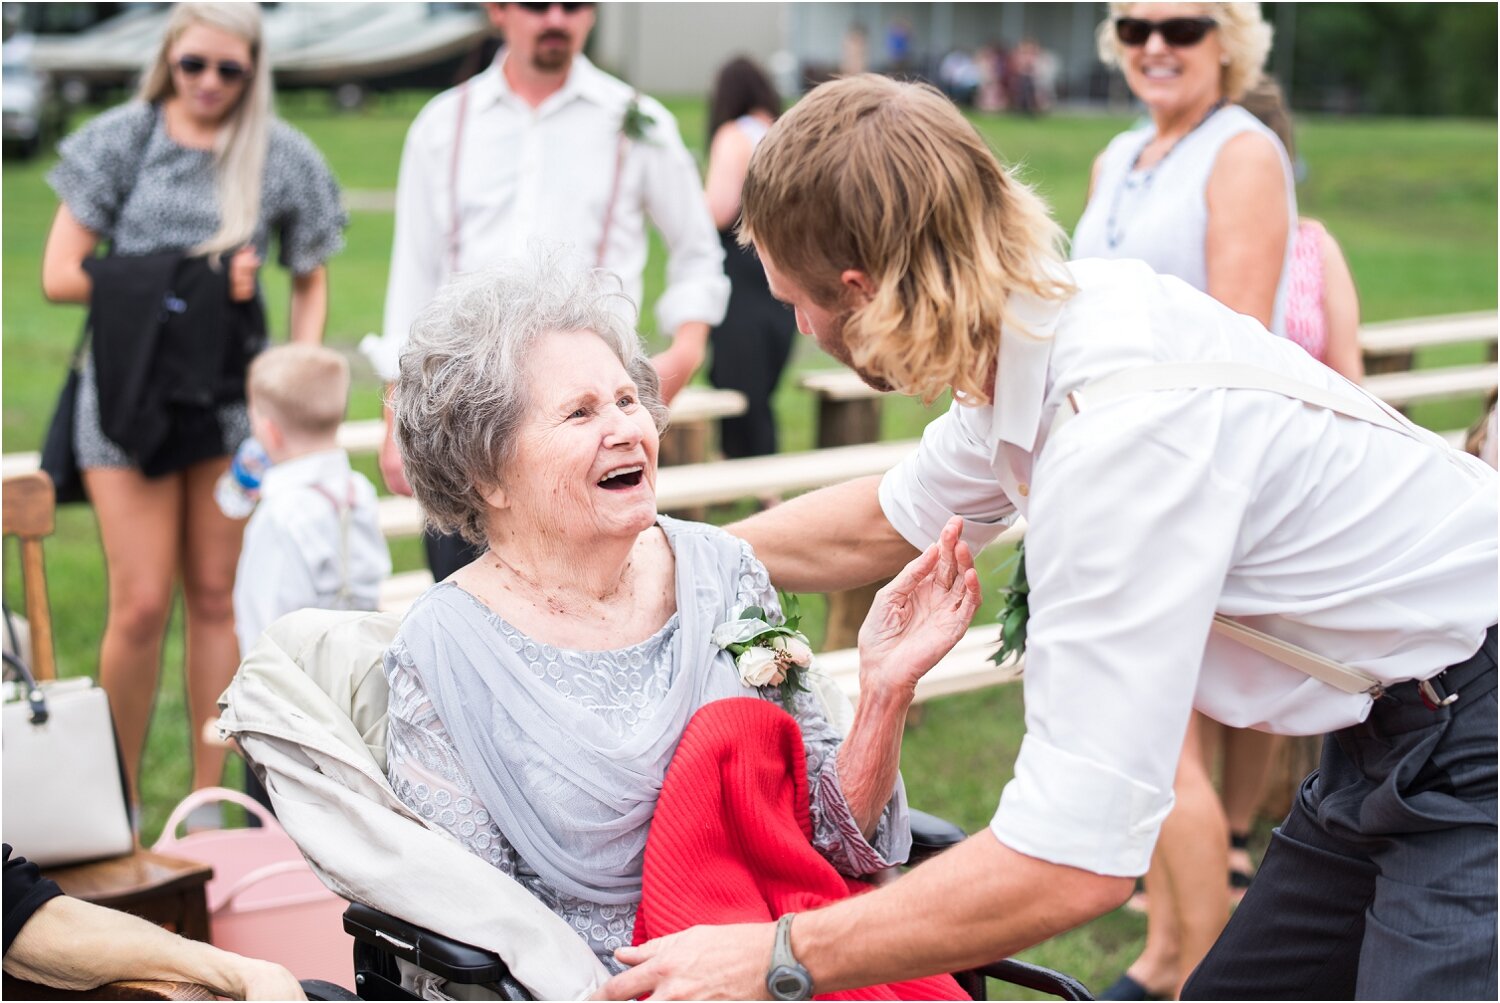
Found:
[42,3,345,799]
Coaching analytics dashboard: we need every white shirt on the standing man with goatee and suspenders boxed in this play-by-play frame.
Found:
[363,51,729,379]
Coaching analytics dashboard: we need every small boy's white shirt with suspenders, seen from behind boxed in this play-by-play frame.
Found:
[234,450,390,652]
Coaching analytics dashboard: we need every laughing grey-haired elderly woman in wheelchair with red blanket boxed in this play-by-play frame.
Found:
[219,256,1088,999]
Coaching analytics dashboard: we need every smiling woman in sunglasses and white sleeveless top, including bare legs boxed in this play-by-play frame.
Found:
[1073,3,1298,1000]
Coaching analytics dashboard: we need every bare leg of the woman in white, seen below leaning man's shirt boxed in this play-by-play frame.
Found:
[1128,714,1229,999]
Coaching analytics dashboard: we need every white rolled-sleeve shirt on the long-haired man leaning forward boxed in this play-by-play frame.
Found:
[881,259,1500,876]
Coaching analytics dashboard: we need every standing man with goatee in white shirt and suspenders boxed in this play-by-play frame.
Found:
[363,3,729,582]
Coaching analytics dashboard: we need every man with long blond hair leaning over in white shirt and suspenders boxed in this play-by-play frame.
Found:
[591,76,1500,1000]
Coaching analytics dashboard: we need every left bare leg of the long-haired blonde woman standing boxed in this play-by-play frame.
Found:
[83,466,182,804]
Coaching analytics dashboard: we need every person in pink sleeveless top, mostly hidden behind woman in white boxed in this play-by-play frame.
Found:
[1224,79,1365,379]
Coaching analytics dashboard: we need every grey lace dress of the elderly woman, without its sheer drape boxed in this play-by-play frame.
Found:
[386,520,911,972]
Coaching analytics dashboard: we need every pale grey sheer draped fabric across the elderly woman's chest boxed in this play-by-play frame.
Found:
[401,517,755,904]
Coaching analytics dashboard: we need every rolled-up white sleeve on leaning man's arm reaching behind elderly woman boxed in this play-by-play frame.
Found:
[881,403,1016,552]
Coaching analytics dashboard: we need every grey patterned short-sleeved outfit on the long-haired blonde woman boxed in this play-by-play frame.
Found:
[47,100,348,468]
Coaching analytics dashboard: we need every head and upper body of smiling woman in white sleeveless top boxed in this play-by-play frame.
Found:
[1073,3,1298,334]
